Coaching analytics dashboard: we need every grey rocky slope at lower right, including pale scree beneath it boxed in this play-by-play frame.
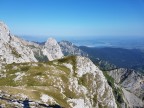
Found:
[107,68,144,107]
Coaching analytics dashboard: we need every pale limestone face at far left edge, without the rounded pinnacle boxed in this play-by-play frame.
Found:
[0,22,37,64]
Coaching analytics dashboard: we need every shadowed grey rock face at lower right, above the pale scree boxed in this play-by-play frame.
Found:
[108,68,144,99]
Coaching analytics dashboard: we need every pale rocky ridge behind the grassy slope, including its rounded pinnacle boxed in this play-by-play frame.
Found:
[0,22,63,64]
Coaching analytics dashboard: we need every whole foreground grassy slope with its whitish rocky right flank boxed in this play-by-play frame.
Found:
[0,56,117,108]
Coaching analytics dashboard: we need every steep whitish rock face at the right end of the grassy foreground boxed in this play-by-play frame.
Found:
[73,56,117,108]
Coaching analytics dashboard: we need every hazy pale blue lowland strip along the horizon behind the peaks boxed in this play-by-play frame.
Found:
[21,36,144,50]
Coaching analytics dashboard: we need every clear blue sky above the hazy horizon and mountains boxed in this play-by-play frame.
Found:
[0,0,144,38]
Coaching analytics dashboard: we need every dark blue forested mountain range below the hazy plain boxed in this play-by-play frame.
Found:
[80,46,144,69]
